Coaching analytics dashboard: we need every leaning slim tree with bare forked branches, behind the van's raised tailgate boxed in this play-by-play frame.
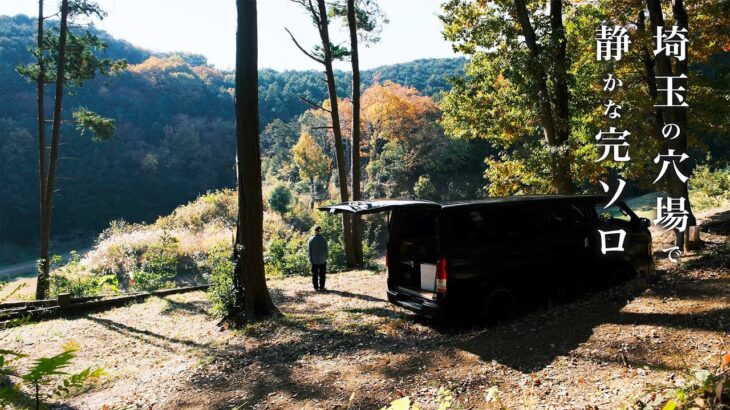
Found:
[287,0,355,267]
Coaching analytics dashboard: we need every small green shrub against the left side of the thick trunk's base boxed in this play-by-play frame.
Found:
[206,243,235,316]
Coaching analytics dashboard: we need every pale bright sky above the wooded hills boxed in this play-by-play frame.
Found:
[0,0,454,70]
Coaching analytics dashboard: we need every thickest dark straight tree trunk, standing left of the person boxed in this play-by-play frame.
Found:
[232,0,279,323]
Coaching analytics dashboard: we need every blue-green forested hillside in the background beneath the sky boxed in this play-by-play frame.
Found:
[0,14,466,263]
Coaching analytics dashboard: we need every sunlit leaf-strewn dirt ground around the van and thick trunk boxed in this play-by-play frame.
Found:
[0,211,730,409]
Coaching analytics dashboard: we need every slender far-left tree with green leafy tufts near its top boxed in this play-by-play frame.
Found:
[18,0,126,299]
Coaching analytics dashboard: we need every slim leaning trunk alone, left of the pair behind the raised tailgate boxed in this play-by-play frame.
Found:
[317,0,355,267]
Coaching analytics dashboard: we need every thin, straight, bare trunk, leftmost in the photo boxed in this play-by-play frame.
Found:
[36,0,48,299]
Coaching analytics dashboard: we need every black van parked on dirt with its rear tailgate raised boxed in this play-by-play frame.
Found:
[319,195,653,318]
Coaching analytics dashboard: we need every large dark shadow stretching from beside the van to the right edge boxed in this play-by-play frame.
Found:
[456,270,730,372]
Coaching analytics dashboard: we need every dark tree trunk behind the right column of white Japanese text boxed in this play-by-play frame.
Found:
[646,0,697,250]
